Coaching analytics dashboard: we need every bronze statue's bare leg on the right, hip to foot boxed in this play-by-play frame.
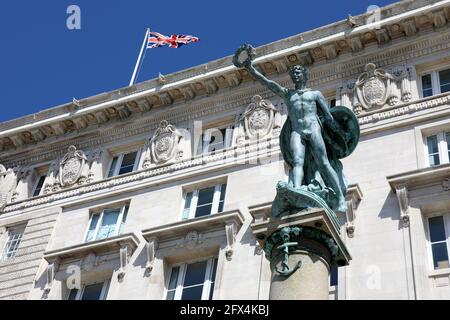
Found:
[310,125,346,211]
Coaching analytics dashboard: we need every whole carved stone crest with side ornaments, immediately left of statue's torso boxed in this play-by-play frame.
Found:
[236,95,282,145]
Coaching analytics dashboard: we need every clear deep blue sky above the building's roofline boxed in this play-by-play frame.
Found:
[0,0,395,121]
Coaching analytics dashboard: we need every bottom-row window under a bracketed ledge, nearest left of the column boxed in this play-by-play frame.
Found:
[166,258,217,300]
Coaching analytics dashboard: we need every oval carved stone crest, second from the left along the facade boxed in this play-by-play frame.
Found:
[59,146,87,187]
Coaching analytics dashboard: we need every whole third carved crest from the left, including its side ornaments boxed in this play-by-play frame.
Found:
[142,120,185,169]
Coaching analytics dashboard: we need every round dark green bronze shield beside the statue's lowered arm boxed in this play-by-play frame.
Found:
[325,106,359,159]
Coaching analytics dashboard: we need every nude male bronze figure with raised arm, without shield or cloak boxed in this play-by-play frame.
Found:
[235,48,346,212]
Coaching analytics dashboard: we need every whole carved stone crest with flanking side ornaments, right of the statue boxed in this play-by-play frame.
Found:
[341,63,411,114]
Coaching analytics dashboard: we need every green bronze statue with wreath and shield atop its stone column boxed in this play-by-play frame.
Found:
[233,45,359,299]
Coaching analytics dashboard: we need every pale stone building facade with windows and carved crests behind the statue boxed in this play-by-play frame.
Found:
[0,0,450,300]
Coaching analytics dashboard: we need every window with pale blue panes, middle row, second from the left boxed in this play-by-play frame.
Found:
[85,206,128,242]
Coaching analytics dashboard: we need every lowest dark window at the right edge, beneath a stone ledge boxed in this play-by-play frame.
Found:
[428,214,450,269]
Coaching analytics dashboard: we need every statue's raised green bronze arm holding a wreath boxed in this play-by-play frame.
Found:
[233,44,287,98]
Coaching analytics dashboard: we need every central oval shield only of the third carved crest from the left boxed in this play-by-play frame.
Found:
[150,120,183,164]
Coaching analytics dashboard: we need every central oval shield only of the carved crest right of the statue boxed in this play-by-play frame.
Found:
[356,63,394,110]
